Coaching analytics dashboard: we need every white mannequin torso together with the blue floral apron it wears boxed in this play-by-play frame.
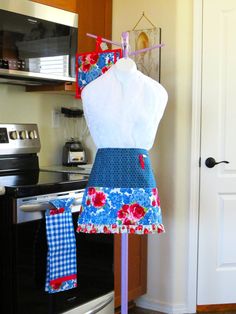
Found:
[77,58,168,234]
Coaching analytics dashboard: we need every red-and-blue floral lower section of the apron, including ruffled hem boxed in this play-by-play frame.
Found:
[77,187,164,234]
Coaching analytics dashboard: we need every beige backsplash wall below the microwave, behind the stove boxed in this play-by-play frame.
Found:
[0,84,90,166]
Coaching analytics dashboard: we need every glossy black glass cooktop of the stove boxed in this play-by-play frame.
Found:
[0,170,88,197]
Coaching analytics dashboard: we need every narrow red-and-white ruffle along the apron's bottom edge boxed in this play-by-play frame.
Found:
[76,224,165,234]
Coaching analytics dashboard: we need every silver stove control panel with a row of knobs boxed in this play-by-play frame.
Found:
[0,124,41,155]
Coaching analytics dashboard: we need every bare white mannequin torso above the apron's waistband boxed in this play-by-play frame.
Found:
[82,59,168,150]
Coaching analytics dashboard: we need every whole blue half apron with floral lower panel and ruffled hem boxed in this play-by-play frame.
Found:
[77,148,164,234]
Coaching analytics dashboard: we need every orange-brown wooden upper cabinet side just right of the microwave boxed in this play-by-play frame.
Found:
[78,0,112,52]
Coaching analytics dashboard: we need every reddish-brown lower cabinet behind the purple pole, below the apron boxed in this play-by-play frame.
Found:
[114,234,147,307]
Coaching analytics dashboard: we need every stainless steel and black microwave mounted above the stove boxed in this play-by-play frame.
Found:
[0,0,78,85]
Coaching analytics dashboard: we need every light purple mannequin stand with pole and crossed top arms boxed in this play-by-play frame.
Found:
[87,32,164,314]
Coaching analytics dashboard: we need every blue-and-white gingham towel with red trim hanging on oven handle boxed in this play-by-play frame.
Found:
[45,198,77,293]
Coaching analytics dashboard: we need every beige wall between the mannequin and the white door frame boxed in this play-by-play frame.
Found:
[113,0,192,312]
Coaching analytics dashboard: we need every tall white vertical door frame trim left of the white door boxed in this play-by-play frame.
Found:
[186,0,203,313]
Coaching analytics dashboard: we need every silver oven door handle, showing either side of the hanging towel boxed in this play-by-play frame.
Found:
[19,197,82,213]
